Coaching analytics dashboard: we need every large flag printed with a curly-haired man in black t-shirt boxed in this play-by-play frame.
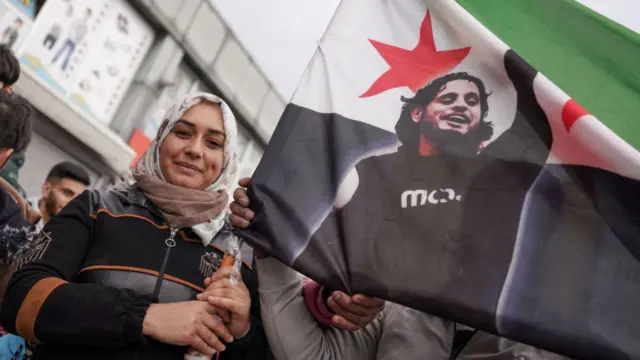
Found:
[242,0,640,359]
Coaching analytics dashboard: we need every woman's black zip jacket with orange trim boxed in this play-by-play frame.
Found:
[1,188,268,360]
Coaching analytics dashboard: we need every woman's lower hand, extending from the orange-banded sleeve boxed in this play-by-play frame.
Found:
[142,301,233,355]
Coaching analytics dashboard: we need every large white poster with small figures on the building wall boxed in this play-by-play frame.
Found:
[19,0,153,124]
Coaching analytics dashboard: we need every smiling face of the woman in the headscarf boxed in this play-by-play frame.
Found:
[160,101,225,190]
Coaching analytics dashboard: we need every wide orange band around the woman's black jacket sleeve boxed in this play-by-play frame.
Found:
[16,277,67,343]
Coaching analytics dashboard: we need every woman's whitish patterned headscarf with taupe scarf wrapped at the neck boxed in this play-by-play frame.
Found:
[133,92,238,246]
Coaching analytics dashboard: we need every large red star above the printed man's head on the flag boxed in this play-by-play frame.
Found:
[360,11,471,98]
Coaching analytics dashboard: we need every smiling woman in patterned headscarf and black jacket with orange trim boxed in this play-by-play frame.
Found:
[2,93,268,360]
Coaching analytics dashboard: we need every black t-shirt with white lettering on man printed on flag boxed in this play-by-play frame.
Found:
[315,120,548,329]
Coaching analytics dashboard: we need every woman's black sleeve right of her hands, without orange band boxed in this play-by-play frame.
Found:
[220,260,270,360]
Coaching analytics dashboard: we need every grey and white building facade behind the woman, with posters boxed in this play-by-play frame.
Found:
[0,0,285,195]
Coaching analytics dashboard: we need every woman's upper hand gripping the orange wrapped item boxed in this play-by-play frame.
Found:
[197,267,251,339]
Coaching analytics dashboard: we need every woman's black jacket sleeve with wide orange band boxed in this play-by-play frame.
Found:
[0,191,151,348]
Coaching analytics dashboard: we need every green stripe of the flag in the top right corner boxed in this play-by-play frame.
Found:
[458,0,640,149]
